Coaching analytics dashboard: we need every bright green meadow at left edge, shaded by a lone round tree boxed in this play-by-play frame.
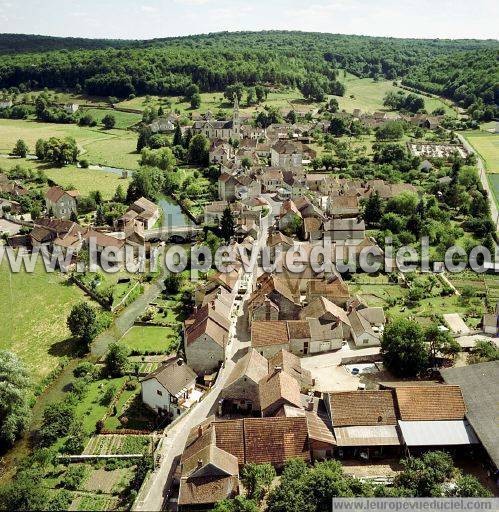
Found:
[0,261,89,383]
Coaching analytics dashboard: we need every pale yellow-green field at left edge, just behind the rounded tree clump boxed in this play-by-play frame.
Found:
[0,119,139,169]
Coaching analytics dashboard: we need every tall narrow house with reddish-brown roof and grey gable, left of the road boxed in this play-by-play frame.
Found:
[184,300,230,374]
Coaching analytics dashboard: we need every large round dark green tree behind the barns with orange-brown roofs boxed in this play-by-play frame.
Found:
[380,318,428,377]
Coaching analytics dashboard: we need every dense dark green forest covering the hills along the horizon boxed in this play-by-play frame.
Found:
[0,31,499,115]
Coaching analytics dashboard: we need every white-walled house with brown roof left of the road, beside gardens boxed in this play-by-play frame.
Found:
[140,357,201,419]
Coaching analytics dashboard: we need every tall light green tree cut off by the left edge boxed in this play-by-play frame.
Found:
[0,350,31,446]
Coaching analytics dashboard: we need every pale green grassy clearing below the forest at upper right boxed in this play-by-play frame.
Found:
[336,72,456,117]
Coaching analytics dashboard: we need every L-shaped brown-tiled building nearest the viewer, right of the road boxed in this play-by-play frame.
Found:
[178,417,311,511]
